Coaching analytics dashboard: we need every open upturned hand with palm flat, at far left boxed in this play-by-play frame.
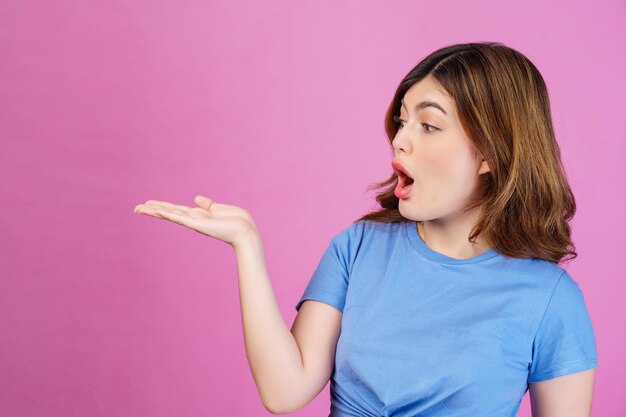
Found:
[133,195,258,247]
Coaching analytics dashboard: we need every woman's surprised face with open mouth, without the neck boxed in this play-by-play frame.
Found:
[392,77,489,221]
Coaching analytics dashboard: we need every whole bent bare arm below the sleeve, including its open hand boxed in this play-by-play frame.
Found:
[134,195,341,414]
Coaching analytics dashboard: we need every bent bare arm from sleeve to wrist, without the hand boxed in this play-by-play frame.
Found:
[233,232,342,414]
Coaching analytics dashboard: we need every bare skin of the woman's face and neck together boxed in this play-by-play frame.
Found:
[392,73,490,259]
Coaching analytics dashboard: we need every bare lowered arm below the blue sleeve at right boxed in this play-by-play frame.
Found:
[528,369,595,417]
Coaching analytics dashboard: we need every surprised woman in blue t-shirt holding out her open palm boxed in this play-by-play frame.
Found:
[135,42,597,417]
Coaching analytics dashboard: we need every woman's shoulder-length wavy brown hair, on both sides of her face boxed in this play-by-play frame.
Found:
[353,42,578,263]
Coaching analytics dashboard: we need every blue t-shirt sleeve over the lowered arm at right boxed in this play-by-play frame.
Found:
[528,270,598,383]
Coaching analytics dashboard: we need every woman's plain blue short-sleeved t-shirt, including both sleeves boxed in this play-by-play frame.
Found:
[295,221,598,417]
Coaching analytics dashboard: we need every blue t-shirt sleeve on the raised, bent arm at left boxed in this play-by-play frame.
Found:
[295,224,361,313]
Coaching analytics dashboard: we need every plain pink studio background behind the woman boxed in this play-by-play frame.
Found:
[0,0,626,417]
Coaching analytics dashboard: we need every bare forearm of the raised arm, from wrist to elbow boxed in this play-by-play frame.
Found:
[235,233,304,411]
